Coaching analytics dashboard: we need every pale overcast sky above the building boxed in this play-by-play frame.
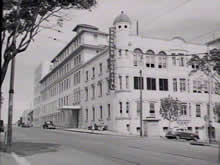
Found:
[2,0,220,121]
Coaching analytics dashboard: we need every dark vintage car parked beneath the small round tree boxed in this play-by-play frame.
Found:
[165,131,199,141]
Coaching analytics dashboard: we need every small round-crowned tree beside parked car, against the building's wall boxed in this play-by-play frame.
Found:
[160,96,182,129]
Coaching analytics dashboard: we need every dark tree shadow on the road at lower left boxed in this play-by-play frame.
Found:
[0,142,60,156]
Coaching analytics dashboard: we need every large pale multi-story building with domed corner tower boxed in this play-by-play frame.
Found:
[36,12,220,141]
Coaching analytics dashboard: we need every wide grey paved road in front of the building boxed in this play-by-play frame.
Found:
[0,128,219,165]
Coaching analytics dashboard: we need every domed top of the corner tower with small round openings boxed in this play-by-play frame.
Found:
[113,11,131,49]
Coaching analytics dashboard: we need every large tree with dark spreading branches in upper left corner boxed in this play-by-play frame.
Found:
[0,0,96,87]
